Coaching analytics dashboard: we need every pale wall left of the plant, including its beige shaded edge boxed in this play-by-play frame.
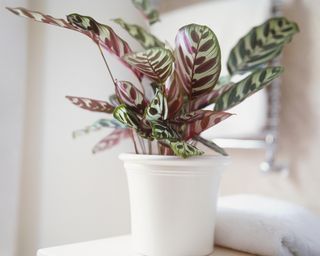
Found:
[15,0,143,256]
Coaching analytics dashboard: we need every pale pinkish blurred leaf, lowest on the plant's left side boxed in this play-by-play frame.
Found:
[92,129,131,154]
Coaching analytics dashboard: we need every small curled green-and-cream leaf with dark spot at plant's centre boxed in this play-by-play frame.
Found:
[145,90,168,122]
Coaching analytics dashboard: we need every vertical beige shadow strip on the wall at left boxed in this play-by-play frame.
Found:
[14,1,46,256]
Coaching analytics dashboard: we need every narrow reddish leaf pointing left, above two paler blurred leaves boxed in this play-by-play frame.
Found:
[66,96,114,114]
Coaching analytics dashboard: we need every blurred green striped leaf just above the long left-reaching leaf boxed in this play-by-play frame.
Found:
[113,18,165,49]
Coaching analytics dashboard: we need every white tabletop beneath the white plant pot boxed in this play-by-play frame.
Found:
[37,235,249,256]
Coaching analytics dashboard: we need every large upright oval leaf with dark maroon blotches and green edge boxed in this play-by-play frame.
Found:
[175,24,221,98]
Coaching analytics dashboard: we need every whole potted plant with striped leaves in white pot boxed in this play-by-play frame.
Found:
[8,0,298,256]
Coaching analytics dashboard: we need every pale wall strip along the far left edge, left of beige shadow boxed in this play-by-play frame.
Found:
[0,0,27,256]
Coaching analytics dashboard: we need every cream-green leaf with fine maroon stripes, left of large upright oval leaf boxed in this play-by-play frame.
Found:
[124,47,173,84]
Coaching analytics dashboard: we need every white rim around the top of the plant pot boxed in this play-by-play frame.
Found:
[119,153,231,166]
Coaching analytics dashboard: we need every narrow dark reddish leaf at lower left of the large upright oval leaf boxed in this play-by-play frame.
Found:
[165,71,183,119]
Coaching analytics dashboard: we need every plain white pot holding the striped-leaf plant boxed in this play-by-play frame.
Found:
[120,154,229,256]
